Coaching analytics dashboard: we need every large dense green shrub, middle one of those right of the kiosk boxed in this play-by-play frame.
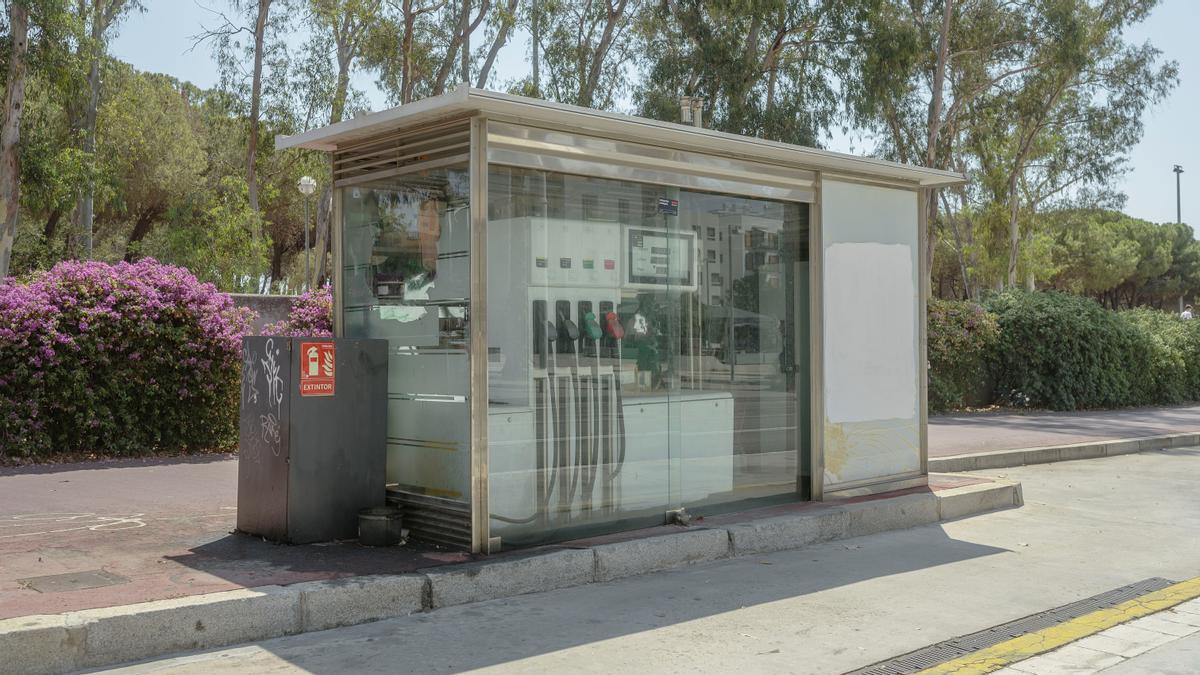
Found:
[985,291,1147,410]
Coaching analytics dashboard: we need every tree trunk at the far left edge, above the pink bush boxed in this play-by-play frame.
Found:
[0,0,29,280]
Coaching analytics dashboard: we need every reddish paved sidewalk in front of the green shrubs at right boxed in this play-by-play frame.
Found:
[929,406,1200,458]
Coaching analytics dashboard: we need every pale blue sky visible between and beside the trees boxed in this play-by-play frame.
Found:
[112,0,1200,222]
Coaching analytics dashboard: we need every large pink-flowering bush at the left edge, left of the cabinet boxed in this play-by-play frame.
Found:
[0,258,250,455]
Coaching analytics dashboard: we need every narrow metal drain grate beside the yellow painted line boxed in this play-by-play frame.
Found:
[847,577,1174,675]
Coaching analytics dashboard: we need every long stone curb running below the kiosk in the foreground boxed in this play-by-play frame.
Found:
[0,482,1021,674]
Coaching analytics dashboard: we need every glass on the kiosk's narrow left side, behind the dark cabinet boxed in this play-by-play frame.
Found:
[338,166,470,501]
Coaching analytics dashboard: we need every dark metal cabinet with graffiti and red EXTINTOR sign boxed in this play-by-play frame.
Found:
[238,336,388,544]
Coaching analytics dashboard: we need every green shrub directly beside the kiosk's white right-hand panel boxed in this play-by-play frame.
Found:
[926,298,1000,411]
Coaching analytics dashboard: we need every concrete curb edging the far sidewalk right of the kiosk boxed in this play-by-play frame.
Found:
[929,432,1200,473]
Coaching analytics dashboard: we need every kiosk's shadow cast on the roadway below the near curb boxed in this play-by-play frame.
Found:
[154,511,1007,674]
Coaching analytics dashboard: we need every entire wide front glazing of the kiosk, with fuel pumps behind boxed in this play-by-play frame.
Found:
[487,166,808,546]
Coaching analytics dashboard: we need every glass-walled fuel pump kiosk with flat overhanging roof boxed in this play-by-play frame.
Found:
[276,86,962,552]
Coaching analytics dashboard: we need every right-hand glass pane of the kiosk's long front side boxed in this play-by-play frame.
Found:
[666,191,809,504]
